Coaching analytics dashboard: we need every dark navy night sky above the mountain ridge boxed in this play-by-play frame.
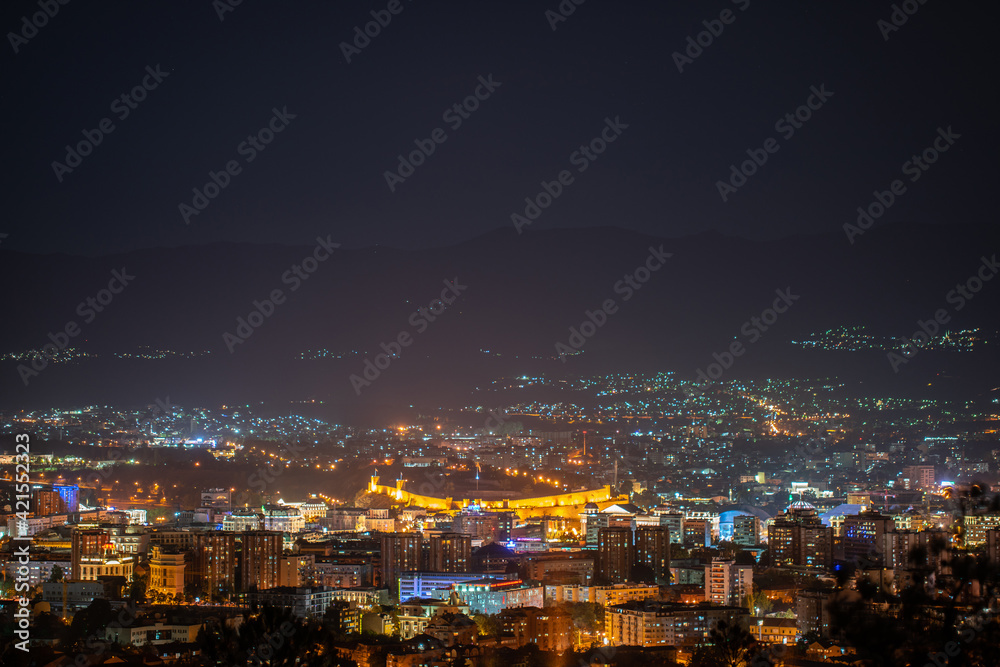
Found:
[0,0,998,255]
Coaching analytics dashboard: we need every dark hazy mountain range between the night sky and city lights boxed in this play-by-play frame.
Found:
[0,224,1000,418]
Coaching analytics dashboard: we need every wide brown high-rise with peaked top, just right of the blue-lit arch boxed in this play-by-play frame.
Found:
[767,501,833,569]
